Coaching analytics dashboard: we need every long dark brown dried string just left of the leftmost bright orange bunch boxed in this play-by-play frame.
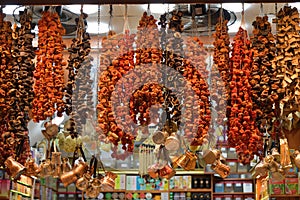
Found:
[8,9,35,164]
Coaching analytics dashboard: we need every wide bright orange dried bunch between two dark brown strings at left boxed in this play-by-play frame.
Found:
[32,11,66,122]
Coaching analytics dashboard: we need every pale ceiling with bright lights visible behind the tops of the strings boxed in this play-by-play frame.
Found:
[4,3,300,40]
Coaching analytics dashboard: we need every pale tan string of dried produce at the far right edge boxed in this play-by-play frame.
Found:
[272,6,300,130]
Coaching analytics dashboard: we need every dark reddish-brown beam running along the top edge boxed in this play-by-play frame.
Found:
[0,0,299,5]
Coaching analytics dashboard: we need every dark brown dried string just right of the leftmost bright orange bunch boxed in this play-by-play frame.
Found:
[65,13,93,137]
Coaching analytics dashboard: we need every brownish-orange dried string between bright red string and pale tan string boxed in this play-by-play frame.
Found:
[250,16,280,132]
